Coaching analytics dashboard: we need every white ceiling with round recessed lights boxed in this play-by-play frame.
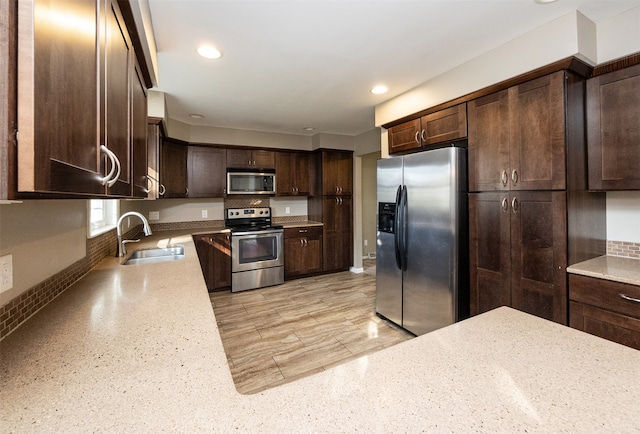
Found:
[149,0,640,135]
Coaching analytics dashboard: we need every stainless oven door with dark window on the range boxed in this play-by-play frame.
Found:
[231,229,284,273]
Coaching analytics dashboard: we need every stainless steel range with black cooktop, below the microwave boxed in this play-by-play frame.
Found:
[225,208,284,292]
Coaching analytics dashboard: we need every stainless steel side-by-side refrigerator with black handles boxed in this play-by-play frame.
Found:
[376,146,469,335]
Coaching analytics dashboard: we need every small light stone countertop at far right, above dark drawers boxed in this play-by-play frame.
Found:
[567,256,640,286]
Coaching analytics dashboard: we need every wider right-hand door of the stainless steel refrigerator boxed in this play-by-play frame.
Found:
[402,148,466,335]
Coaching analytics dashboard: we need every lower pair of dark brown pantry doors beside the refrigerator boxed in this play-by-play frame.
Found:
[469,191,567,324]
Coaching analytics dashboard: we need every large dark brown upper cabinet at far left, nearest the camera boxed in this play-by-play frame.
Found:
[17,0,146,197]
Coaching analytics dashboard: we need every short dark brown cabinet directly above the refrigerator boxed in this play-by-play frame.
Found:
[388,103,467,154]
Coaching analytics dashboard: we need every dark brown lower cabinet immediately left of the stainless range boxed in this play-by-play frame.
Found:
[193,233,231,291]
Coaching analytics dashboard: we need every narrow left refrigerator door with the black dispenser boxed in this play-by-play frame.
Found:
[376,158,402,325]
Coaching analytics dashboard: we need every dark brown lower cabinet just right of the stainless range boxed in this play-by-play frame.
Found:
[284,226,322,279]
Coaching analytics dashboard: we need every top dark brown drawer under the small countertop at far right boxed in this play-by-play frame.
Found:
[569,274,640,319]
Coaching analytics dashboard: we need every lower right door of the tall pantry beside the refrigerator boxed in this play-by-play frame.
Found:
[509,191,568,324]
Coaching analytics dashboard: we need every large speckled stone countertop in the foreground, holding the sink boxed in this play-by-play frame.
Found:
[0,231,640,433]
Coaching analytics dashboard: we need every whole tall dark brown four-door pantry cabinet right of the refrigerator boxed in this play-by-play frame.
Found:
[468,71,606,324]
